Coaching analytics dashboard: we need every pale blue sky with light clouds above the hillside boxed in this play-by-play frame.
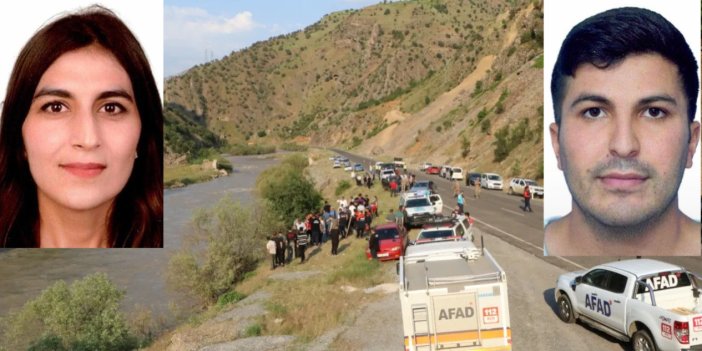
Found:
[164,0,390,77]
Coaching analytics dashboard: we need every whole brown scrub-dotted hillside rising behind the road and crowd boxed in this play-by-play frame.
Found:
[165,0,543,178]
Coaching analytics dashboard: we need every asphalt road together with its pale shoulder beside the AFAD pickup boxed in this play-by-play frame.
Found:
[333,150,702,351]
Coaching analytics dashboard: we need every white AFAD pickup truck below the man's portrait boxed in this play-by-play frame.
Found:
[555,259,702,351]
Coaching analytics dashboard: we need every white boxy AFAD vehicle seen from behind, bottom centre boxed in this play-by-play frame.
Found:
[398,241,512,351]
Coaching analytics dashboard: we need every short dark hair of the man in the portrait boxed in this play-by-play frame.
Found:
[551,7,699,125]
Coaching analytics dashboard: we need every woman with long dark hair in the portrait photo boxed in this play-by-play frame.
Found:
[0,6,163,247]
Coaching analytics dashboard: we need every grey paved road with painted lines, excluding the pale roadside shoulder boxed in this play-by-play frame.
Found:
[333,149,702,274]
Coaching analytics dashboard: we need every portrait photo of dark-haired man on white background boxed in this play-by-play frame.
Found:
[544,1,702,256]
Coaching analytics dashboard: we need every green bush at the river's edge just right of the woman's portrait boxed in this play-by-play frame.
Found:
[167,197,276,306]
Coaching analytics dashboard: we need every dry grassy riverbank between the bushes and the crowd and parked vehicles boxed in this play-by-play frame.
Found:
[149,150,402,350]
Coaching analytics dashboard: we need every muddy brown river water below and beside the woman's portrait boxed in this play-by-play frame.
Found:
[0,156,278,318]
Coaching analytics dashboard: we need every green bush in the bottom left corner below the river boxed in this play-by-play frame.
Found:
[0,273,137,351]
